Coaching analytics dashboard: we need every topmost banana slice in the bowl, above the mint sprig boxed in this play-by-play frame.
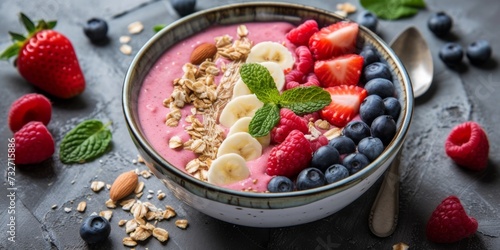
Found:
[246,42,295,70]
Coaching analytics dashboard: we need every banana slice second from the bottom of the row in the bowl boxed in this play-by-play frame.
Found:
[217,132,262,161]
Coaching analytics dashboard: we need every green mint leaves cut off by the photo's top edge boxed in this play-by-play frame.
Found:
[360,0,425,20]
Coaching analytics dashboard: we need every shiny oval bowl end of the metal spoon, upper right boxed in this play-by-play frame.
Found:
[390,26,434,98]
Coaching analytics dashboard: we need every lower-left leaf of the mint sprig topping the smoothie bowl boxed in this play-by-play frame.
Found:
[248,103,280,137]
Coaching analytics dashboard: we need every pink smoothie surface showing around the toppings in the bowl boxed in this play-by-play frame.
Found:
[138,22,294,192]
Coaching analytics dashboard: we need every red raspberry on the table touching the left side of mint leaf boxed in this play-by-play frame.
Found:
[14,121,55,164]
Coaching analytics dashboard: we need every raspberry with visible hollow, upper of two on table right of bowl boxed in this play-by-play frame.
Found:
[445,122,490,170]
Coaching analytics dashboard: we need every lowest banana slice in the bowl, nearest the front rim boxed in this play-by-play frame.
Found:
[208,153,250,185]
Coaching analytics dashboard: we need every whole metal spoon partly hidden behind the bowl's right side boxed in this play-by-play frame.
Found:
[369,26,433,237]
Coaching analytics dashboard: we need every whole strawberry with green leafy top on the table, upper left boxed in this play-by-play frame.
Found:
[0,13,85,98]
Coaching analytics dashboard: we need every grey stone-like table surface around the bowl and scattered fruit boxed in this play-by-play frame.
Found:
[0,0,500,249]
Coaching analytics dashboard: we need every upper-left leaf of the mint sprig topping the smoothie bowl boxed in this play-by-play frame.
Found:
[240,63,280,103]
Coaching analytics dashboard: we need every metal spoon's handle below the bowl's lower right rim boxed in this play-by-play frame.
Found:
[368,149,402,237]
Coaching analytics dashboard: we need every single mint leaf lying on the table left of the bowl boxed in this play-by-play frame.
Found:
[59,120,111,163]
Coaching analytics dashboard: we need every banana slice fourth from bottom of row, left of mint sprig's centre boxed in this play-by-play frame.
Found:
[219,94,264,128]
